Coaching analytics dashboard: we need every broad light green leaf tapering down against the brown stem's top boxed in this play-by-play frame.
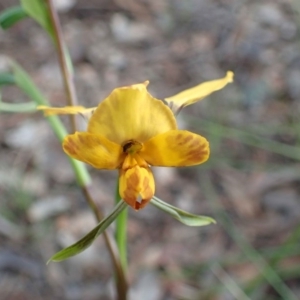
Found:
[20,0,54,38]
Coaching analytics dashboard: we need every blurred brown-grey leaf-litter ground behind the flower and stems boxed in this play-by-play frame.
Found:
[0,0,300,300]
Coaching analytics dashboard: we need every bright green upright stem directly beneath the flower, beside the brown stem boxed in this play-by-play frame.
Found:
[115,182,128,272]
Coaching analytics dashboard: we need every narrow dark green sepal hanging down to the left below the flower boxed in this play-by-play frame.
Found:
[47,201,127,264]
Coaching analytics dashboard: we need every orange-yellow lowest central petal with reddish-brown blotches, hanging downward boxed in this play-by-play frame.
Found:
[119,155,155,210]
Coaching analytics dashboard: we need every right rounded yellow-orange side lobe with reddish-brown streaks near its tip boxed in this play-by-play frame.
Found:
[139,130,209,167]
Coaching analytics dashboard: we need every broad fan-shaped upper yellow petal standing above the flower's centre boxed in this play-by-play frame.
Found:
[88,82,177,145]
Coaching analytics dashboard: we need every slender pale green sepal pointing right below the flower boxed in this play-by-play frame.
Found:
[150,196,216,226]
